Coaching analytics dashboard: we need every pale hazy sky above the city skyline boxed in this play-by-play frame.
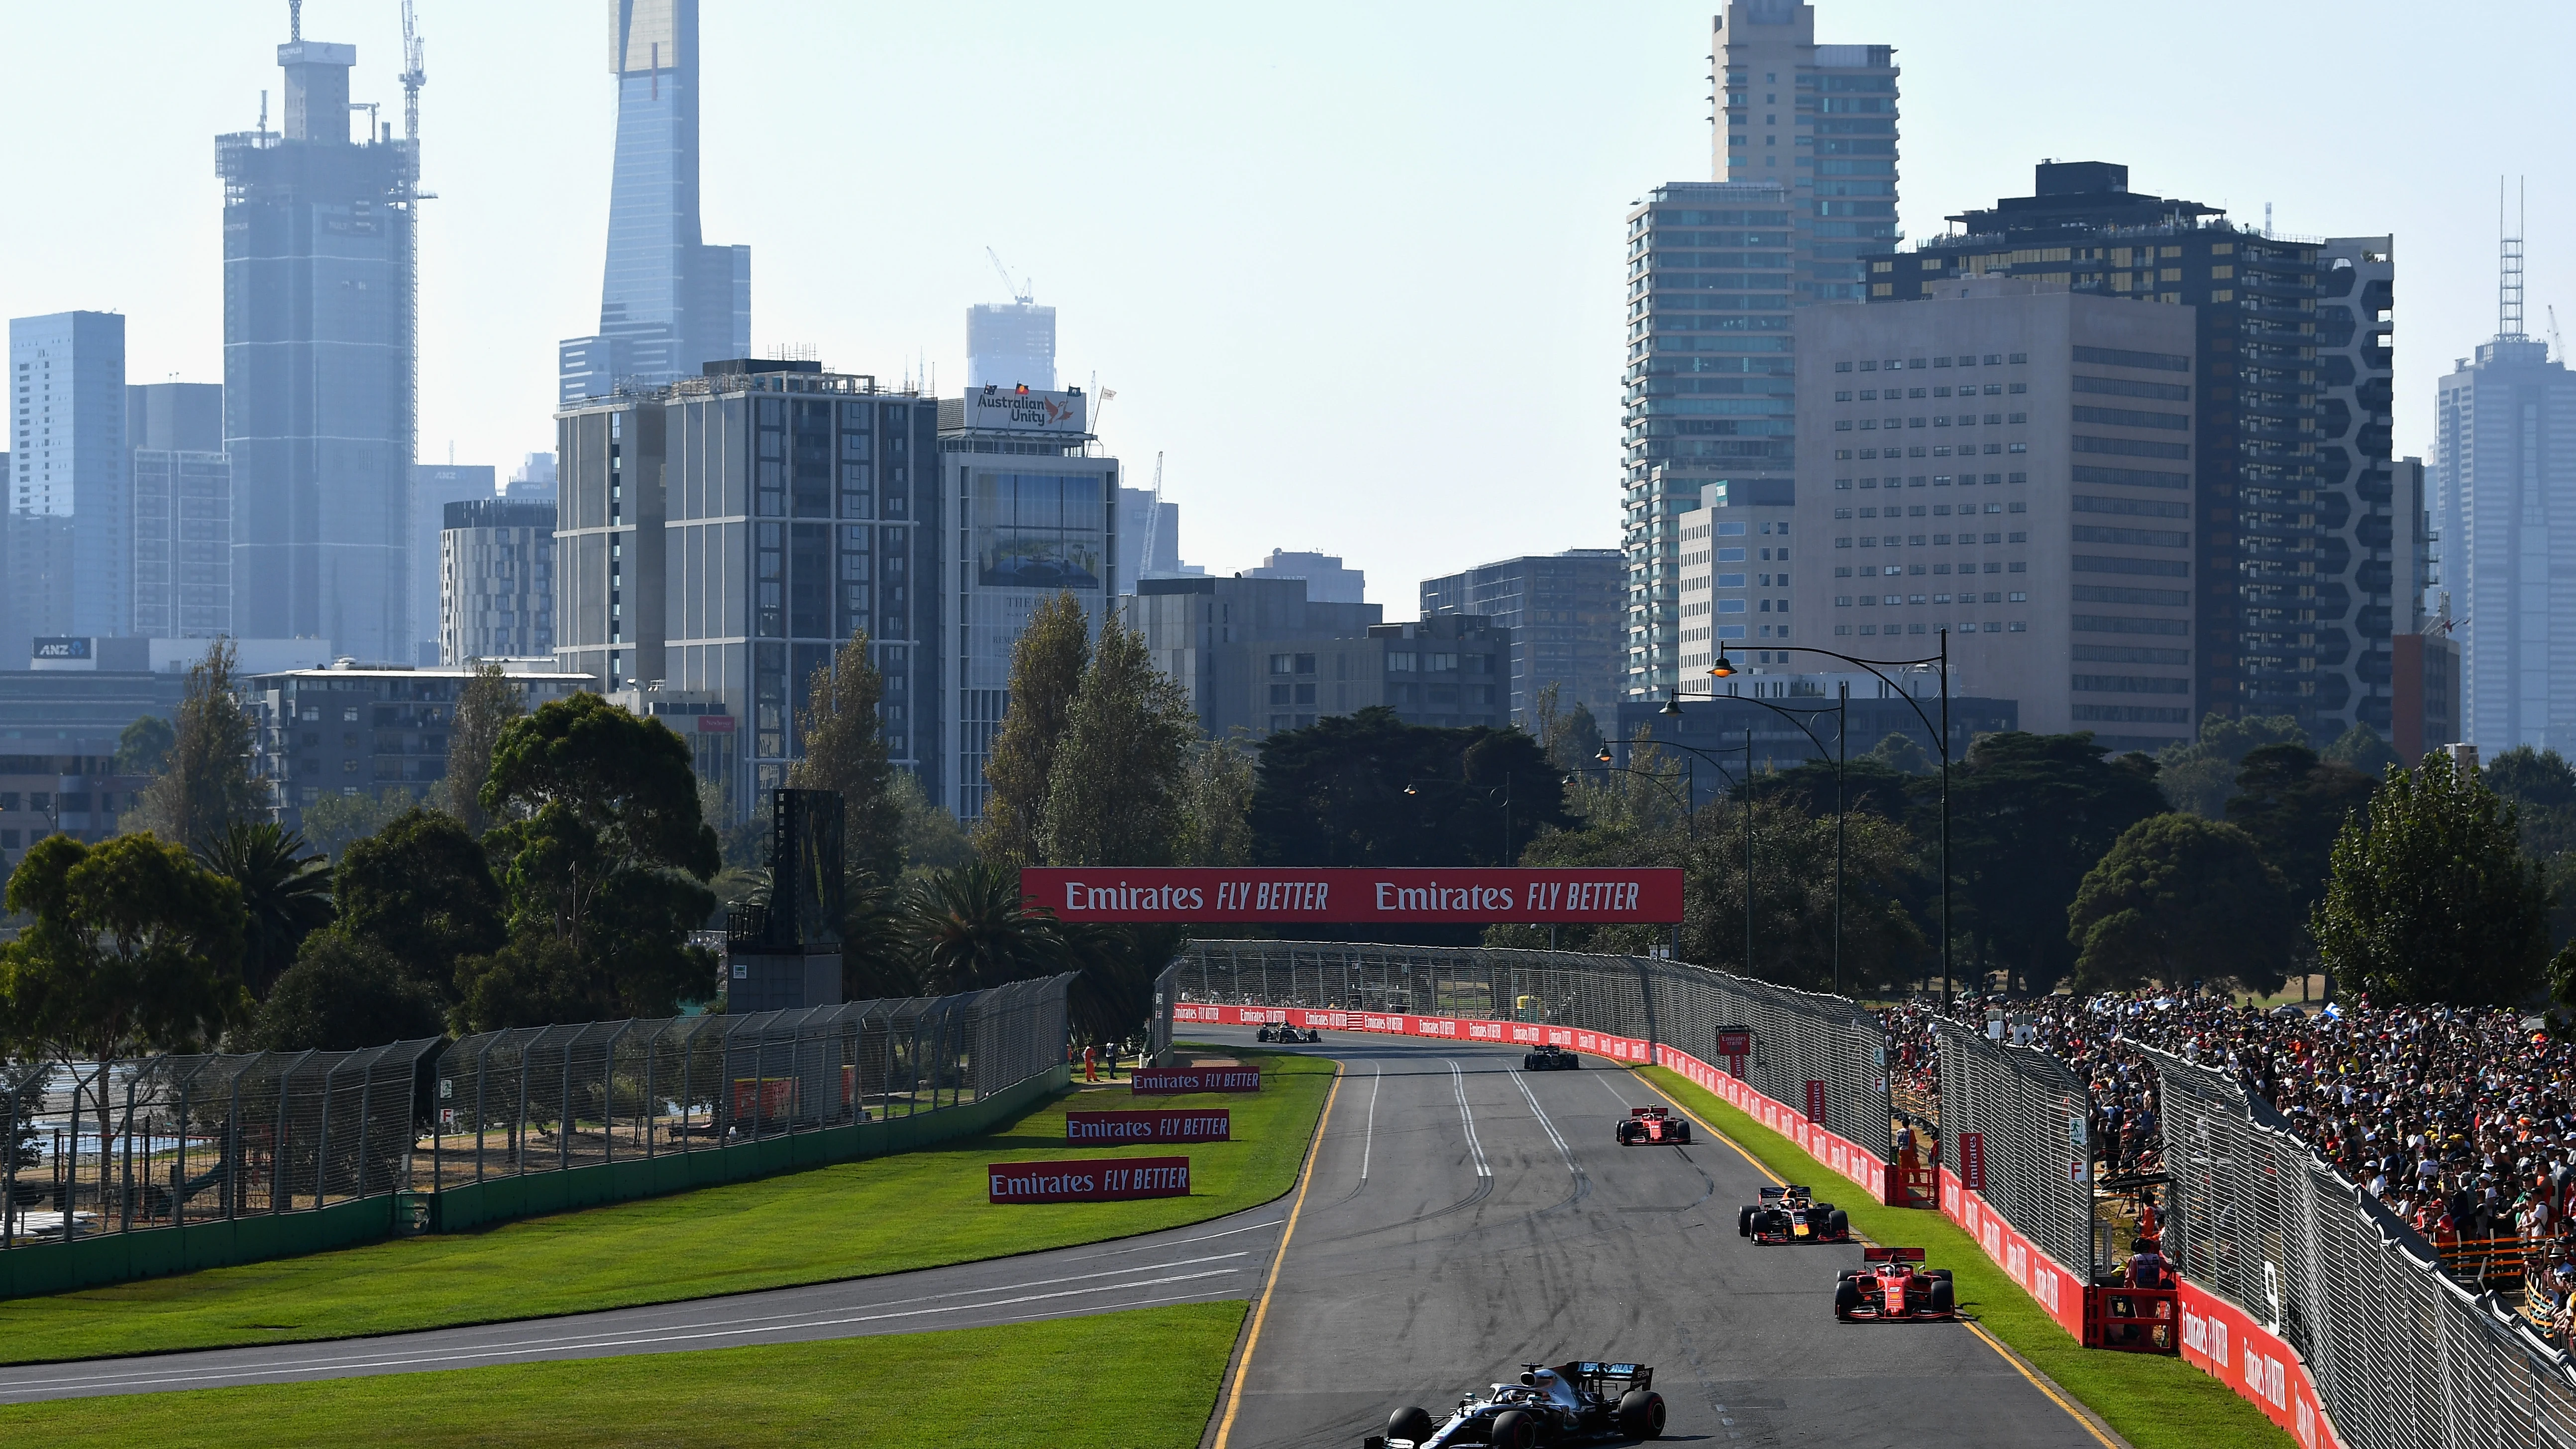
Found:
[0,0,2576,618]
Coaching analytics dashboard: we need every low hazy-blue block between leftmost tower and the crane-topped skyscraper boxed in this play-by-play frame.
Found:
[126,384,232,638]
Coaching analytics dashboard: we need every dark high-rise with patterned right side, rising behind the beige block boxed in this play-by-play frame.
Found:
[1868,162,2403,741]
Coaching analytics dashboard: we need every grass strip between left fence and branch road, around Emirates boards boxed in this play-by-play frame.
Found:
[0,1052,1332,1364]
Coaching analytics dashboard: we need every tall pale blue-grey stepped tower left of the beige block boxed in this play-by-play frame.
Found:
[1620,0,1899,695]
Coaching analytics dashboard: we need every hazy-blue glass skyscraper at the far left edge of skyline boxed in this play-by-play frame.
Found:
[8,311,134,648]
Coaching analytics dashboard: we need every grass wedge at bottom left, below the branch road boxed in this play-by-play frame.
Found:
[0,1302,1244,1449]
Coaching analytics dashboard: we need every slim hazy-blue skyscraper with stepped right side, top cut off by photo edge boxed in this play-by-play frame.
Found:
[559,0,752,407]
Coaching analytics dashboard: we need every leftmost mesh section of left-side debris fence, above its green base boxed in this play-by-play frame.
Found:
[0,1040,440,1251]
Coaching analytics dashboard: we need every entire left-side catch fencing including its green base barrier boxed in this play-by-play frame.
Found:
[0,975,1072,1297]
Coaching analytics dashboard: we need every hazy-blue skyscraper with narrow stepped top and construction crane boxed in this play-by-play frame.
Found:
[218,36,420,664]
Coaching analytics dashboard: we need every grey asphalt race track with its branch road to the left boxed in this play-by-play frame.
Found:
[0,1027,2105,1449]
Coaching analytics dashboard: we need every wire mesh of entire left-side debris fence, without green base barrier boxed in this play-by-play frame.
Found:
[0,975,1072,1251]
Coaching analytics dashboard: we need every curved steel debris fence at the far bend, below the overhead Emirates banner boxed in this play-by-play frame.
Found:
[1175,939,1893,1161]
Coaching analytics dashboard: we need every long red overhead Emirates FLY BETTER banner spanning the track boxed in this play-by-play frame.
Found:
[1020,867,1682,924]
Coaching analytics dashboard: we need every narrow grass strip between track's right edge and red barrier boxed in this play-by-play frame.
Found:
[1636,1065,2293,1449]
